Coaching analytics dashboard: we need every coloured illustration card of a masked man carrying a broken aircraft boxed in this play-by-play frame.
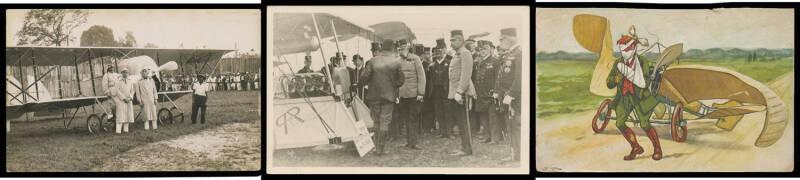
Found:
[535,8,796,173]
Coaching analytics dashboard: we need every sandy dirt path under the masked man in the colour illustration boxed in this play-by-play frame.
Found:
[535,72,794,172]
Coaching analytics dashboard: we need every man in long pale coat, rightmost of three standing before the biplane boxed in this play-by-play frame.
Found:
[133,68,158,130]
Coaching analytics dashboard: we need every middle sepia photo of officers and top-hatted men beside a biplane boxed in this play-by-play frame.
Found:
[266,6,530,174]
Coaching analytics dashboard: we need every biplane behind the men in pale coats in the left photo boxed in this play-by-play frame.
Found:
[5,46,234,133]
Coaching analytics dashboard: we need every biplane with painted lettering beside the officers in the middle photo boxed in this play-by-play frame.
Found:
[272,13,424,156]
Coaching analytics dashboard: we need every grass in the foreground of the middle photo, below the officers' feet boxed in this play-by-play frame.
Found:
[272,132,519,168]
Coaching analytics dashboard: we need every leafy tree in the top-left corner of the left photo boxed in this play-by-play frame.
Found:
[16,9,89,46]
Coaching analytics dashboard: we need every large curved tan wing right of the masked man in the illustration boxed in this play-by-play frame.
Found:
[658,65,789,147]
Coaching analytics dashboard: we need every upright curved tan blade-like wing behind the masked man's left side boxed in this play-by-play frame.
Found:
[572,14,616,96]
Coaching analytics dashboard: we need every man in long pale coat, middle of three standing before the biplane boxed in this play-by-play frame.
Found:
[111,68,134,134]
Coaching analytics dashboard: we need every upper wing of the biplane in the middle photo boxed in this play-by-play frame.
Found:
[272,13,377,56]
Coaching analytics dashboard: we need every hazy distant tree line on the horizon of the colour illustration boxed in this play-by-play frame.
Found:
[535,48,794,62]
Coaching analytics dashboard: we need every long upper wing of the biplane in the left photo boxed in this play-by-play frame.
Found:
[6,46,235,70]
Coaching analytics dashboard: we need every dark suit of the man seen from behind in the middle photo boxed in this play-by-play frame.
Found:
[359,53,405,152]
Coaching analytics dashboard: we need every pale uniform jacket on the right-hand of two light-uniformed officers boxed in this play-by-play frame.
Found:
[447,46,475,99]
